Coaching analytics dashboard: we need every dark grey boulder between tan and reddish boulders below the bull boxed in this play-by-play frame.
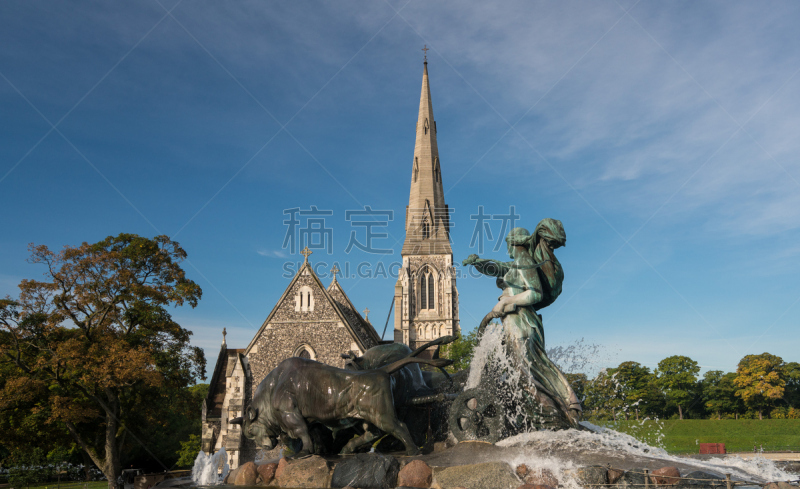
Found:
[331,453,400,489]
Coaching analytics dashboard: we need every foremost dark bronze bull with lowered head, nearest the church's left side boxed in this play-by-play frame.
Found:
[231,357,452,457]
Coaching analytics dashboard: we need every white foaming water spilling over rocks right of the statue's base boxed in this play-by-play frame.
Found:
[497,421,796,489]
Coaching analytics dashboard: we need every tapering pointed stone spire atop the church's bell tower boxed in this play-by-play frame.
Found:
[402,59,452,255]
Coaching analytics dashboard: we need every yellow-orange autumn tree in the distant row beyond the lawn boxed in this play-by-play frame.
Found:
[733,353,786,419]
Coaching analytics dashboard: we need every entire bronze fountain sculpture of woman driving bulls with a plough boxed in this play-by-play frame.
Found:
[231,219,581,456]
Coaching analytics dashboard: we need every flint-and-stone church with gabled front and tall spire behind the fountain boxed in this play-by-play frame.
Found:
[202,58,460,469]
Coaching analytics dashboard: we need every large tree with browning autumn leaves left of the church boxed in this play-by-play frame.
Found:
[0,234,205,489]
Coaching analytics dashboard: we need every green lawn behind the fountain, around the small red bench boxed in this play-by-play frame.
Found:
[595,419,800,453]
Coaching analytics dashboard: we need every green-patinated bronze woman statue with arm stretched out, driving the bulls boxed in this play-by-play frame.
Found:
[463,219,581,428]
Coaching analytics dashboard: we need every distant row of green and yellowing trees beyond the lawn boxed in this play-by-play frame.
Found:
[567,353,800,421]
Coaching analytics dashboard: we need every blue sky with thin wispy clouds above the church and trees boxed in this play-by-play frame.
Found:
[0,0,800,378]
